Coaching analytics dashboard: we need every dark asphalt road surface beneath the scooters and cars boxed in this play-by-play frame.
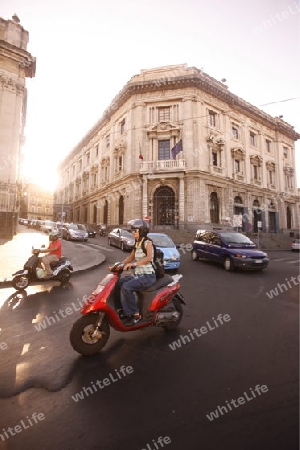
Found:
[0,241,299,450]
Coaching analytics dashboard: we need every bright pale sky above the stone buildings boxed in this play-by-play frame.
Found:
[0,0,300,189]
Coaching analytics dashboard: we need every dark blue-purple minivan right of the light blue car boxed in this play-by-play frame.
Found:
[191,230,269,270]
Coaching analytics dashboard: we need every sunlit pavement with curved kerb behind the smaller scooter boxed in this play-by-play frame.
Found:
[0,225,106,288]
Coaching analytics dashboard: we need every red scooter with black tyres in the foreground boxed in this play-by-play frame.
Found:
[70,263,185,355]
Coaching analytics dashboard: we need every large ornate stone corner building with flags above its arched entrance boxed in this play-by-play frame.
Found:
[55,65,300,232]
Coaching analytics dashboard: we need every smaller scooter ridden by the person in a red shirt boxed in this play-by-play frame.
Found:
[12,248,73,291]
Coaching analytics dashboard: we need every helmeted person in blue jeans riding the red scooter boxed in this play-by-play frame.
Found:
[119,219,156,325]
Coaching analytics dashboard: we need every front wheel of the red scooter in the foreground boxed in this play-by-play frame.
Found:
[70,314,110,356]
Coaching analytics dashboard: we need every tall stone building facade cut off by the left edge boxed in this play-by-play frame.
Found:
[0,15,35,238]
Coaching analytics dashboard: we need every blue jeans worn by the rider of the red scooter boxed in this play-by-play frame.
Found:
[119,273,156,315]
